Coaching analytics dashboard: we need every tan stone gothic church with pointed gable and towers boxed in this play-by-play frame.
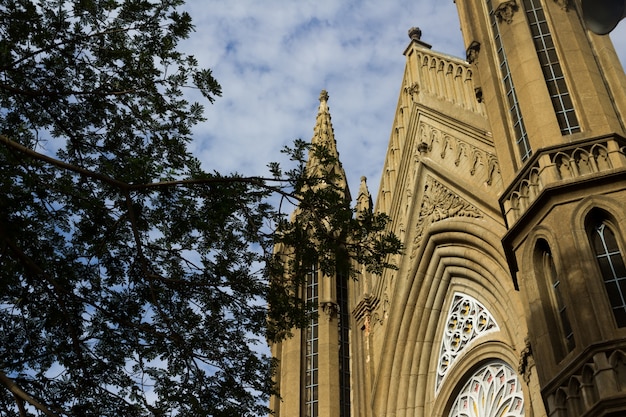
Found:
[270,0,626,417]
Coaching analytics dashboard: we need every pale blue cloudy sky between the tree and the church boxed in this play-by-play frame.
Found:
[176,0,626,202]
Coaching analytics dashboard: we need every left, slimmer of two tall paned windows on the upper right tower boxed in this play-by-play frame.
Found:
[487,0,532,162]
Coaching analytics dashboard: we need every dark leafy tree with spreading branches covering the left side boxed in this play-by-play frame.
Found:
[0,0,400,416]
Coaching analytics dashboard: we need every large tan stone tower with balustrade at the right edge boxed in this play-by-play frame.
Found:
[456,0,626,417]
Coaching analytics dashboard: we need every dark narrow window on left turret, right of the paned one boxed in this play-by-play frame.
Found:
[337,268,350,417]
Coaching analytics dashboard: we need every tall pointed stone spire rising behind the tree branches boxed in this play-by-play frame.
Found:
[307,90,350,199]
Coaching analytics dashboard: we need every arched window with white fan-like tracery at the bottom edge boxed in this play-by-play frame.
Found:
[449,362,524,417]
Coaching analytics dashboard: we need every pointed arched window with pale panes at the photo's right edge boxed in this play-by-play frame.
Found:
[591,221,626,327]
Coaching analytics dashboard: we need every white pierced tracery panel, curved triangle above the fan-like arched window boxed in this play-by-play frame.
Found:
[435,293,499,391]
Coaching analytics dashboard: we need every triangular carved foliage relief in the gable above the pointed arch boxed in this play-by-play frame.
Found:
[411,176,483,259]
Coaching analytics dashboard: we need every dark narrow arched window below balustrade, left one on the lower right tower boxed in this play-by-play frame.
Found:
[538,240,576,352]
